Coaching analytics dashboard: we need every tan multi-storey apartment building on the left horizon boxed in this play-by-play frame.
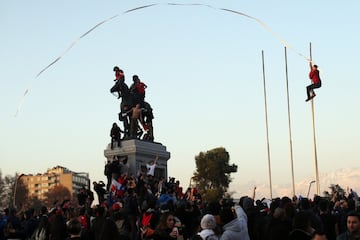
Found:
[21,166,90,200]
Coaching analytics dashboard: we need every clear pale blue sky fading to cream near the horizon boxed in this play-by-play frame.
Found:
[0,0,360,197]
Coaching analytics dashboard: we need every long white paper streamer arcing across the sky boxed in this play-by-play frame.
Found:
[15,3,310,117]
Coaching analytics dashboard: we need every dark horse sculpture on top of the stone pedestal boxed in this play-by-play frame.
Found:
[110,81,154,141]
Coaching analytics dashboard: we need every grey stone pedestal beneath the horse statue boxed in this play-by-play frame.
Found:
[104,139,170,179]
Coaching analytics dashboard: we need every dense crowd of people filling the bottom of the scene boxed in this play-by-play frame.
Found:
[0,159,360,240]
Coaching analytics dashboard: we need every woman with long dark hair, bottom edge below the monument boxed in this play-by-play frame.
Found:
[152,212,179,240]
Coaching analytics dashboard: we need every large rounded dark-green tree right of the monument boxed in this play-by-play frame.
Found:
[193,147,237,201]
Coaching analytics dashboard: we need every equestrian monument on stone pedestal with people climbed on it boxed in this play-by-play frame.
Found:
[104,66,170,179]
